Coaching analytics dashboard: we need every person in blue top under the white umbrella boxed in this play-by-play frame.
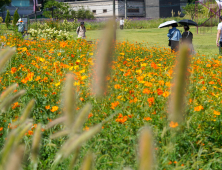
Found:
[167,23,182,52]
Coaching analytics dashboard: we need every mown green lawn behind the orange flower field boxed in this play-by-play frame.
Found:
[80,27,218,55]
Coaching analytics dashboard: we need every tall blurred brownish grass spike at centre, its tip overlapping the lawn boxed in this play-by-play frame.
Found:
[93,20,116,97]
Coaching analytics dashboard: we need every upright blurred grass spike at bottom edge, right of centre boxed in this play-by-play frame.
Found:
[139,127,154,170]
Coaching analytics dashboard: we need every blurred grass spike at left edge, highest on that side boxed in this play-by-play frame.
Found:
[0,48,15,71]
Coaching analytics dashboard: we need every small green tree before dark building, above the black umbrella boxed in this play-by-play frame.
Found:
[183,4,203,20]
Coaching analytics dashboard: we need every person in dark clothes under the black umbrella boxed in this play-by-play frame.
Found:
[182,25,195,54]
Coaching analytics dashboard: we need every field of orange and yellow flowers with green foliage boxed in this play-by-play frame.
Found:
[0,36,222,170]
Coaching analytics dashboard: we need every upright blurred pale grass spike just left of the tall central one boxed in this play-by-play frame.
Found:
[63,74,76,128]
